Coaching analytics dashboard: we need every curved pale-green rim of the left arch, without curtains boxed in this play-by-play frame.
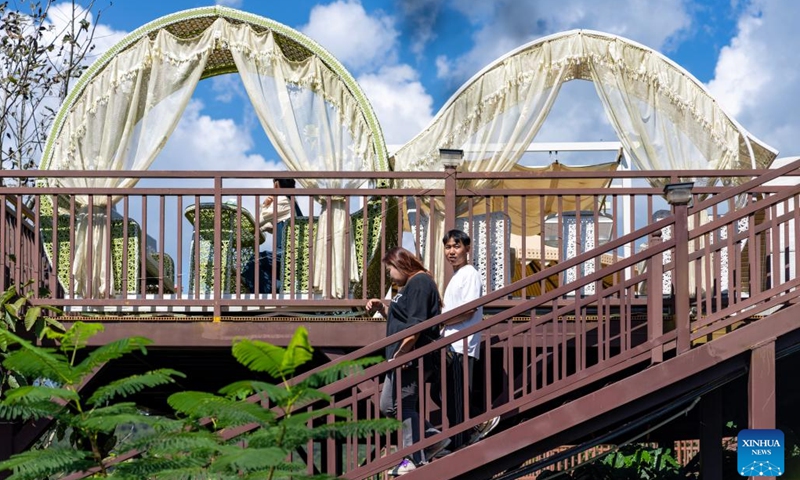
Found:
[39,6,390,187]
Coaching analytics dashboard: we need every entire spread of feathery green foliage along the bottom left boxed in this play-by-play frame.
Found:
[0,322,399,480]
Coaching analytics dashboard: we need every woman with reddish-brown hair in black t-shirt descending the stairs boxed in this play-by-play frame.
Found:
[367,247,450,475]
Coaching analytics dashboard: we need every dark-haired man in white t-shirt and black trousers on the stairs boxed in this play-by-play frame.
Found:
[433,230,499,448]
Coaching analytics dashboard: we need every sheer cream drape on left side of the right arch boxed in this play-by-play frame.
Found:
[395,36,569,289]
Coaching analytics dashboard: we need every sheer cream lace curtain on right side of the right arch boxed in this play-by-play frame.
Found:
[580,34,752,186]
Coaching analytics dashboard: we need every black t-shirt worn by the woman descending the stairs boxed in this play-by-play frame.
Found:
[386,273,442,359]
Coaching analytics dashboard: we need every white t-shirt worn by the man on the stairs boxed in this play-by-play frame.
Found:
[442,264,483,358]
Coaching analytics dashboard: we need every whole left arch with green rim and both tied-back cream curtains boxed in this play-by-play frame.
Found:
[40,6,388,296]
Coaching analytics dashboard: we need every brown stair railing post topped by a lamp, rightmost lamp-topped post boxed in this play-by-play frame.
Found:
[664,182,694,354]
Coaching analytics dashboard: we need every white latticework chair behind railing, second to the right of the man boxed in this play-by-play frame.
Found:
[544,210,614,295]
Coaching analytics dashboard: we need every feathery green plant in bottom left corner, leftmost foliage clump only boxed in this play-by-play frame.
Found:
[0,322,181,480]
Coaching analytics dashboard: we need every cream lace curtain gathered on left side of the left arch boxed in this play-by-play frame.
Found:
[49,24,211,298]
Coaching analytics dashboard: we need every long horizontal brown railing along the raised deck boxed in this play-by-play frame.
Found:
[0,165,792,318]
